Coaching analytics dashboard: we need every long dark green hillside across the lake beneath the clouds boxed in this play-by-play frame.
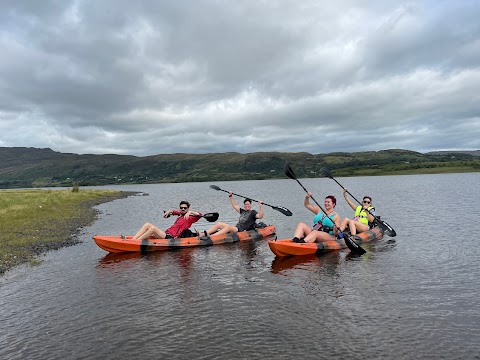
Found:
[0,147,480,189]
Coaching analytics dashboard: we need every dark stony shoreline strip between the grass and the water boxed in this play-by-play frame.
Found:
[0,191,141,276]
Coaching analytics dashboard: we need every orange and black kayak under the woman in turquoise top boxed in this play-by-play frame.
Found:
[268,227,383,256]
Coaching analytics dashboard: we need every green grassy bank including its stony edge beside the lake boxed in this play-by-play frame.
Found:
[0,188,133,274]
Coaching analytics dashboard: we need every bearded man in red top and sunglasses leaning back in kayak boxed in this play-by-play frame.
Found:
[133,201,202,240]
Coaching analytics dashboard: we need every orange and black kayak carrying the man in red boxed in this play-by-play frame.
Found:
[93,225,275,252]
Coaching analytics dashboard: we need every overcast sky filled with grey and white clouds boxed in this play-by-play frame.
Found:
[0,0,480,156]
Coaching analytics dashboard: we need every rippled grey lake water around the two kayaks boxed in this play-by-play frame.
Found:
[0,173,480,359]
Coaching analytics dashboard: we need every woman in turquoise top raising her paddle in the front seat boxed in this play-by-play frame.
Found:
[292,192,340,243]
